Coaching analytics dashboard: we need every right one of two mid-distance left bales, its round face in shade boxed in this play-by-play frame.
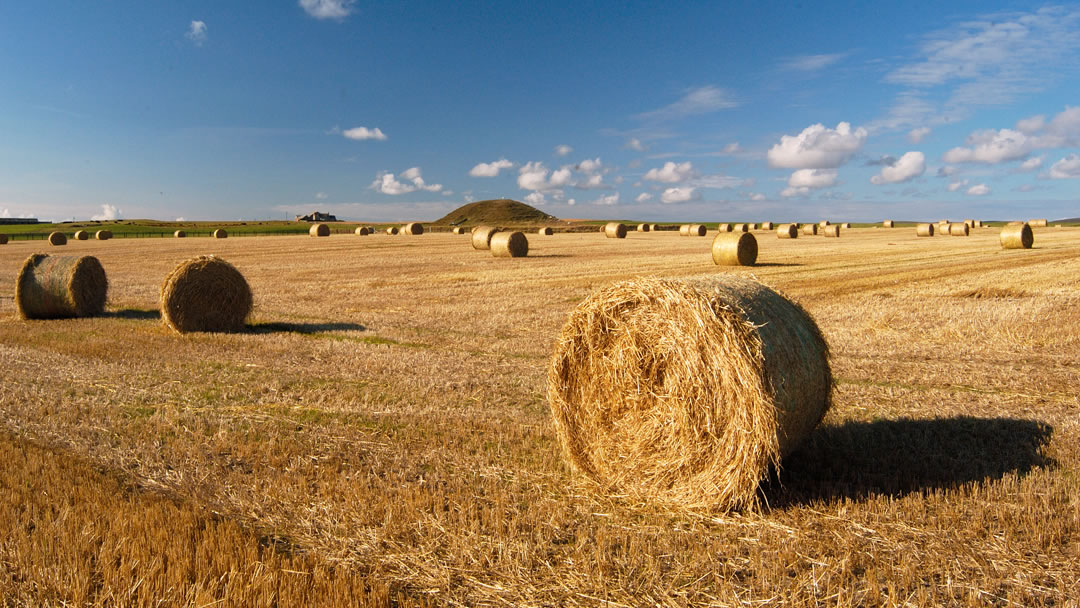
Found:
[161,256,252,334]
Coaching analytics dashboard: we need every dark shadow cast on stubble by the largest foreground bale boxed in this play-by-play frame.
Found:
[762,417,1054,509]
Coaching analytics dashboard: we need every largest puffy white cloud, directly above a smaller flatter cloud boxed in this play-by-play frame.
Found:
[768,122,866,168]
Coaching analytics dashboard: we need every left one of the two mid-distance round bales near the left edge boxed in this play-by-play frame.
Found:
[15,254,109,319]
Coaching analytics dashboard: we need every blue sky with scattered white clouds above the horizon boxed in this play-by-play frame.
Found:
[0,0,1080,221]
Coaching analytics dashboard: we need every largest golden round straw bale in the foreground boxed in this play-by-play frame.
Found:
[548,276,833,510]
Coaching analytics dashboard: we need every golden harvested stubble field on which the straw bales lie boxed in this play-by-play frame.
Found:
[0,228,1080,606]
